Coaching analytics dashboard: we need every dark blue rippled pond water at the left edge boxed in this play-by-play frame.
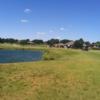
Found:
[0,50,43,63]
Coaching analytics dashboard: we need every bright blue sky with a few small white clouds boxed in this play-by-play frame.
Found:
[0,0,100,42]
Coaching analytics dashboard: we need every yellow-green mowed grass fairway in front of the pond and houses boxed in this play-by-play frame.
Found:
[0,49,100,100]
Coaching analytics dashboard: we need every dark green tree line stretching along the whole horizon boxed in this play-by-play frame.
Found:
[0,38,100,48]
